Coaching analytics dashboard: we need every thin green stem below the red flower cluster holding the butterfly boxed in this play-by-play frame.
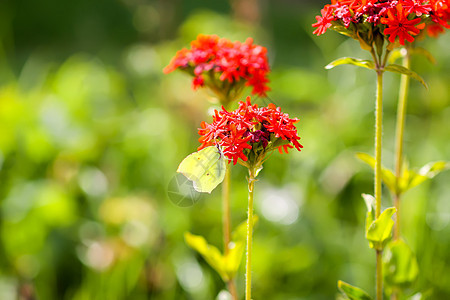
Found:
[245,168,256,300]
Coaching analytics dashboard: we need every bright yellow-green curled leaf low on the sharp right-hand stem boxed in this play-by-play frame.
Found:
[366,207,397,250]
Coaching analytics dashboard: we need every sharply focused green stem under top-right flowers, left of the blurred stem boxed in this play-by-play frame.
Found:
[374,69,383,300]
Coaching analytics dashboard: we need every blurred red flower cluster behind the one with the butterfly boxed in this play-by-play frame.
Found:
[164,34,269,96]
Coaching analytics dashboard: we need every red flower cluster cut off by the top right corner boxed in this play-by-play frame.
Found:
[312,0,450,45]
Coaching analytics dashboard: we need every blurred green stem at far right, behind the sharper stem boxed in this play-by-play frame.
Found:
[394,49,411,240]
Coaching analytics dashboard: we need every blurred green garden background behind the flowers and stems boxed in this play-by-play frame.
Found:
[0,0,450,300]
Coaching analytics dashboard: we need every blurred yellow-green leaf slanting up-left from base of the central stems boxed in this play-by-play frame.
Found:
[184,232,231,282]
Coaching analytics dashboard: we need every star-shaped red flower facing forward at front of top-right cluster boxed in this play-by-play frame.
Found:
[381,3,425,45]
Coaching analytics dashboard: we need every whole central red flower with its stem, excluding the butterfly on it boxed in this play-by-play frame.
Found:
[198,97,303,300]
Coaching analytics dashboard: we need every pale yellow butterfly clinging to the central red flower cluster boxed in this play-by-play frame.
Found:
[177,146,227,193]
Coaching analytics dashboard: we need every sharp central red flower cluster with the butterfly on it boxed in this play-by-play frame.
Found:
[198,97,303,164]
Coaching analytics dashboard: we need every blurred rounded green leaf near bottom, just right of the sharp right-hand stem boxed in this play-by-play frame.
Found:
[383,240,419,289]
